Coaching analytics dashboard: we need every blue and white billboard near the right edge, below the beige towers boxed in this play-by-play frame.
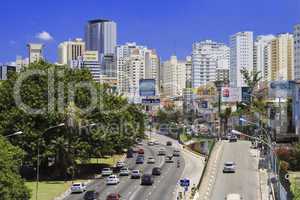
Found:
[269,81,294,98]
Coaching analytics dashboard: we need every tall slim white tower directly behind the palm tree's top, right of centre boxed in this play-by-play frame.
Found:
[229,32,253,87]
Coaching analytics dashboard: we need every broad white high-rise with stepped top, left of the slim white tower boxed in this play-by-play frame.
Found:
[192,40,230,88]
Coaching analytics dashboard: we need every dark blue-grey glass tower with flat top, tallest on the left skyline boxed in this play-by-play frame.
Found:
[85,19,117,63]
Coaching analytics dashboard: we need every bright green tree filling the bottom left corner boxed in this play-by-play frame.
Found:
[0,136,30,200]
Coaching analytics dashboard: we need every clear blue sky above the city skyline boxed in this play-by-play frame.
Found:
[0,0,300,63]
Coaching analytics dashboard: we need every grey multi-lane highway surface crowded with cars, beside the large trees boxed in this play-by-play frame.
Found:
[65,137,185,200]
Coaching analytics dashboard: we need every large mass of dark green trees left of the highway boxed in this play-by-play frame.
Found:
[0,62,144,177]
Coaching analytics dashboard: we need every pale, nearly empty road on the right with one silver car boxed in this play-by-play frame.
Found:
[211,141,259,200]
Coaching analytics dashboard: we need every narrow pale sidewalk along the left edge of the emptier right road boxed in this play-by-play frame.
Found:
[194,141,223,200]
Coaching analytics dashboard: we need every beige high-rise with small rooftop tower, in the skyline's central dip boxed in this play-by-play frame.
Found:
[160,55,186,97]
